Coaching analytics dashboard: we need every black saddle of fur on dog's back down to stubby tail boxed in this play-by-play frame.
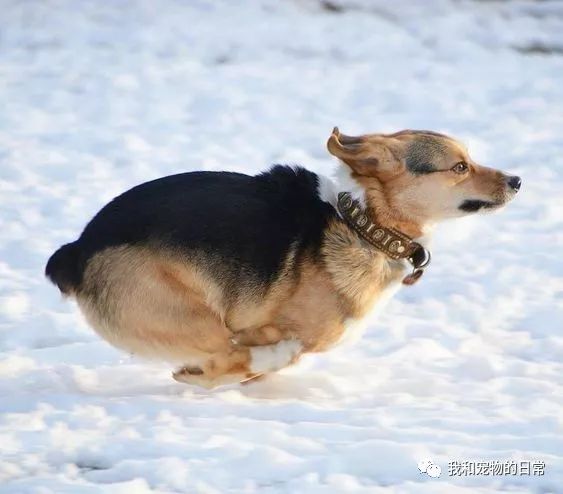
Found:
[47,165,336,296]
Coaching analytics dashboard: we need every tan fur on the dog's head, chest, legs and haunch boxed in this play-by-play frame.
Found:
[68,129,509,387]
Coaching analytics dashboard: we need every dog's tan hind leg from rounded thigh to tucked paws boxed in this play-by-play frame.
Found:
[77,246,302,388]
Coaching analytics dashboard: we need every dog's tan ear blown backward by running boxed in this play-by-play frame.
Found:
[327,127,400,176]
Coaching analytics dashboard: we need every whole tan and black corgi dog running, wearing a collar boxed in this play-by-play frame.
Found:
[46,128,521,388]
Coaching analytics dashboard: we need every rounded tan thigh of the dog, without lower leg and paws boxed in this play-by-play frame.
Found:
[77,246,231,362]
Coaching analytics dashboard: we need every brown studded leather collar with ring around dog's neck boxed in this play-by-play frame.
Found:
[338,192,431,285]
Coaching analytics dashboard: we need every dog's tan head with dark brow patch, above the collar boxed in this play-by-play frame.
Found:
[327,127,520,228]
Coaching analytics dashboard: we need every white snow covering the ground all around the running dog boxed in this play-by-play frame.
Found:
[0,0,563,494]
